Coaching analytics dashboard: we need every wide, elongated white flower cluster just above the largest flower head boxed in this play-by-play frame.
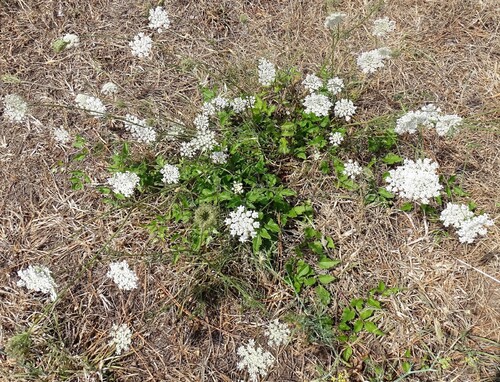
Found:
[394,104,462,136]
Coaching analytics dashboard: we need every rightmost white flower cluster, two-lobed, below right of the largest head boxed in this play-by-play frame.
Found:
[439,203,493,244]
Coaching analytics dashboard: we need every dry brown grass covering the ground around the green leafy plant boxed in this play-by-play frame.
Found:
[0,0,500,381]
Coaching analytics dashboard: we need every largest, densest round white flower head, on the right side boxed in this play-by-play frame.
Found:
[385,158,443,204]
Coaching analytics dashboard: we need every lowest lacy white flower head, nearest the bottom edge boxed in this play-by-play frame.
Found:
[237,339,274,382]
